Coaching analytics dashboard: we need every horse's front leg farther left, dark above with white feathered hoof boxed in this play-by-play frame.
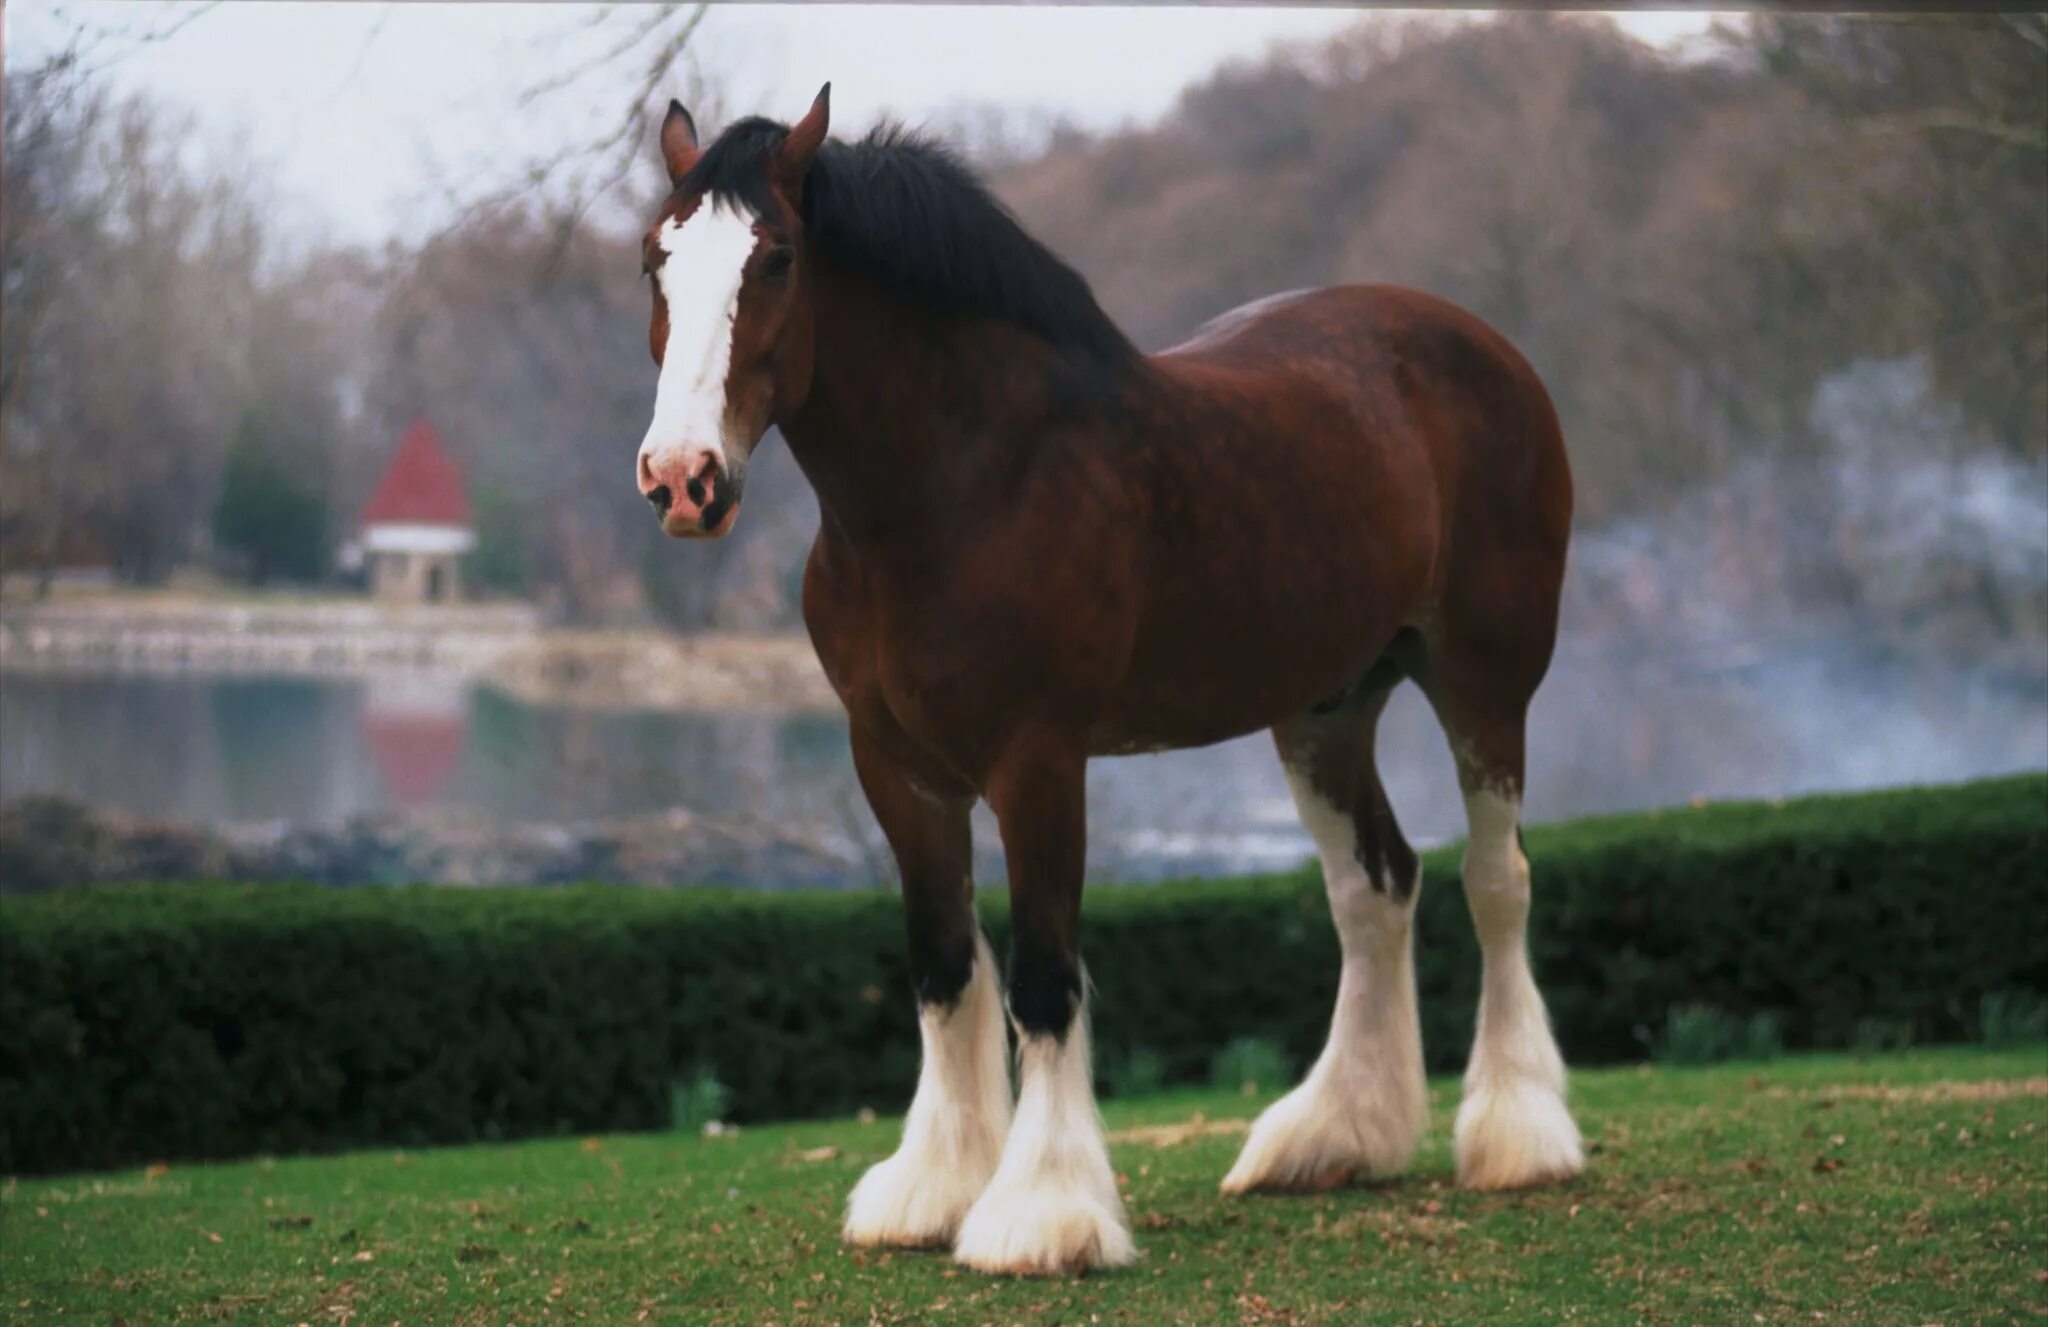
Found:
[844,727,1010,1247]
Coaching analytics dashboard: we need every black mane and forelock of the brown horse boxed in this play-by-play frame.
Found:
[680,117,1137,365]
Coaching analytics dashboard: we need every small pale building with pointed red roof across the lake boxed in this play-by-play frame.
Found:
[360,420,477,604]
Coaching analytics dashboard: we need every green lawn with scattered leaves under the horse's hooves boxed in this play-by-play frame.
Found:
[0,1046,2048,1325]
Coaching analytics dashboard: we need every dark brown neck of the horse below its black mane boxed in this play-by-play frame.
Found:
[780,262,1130,549]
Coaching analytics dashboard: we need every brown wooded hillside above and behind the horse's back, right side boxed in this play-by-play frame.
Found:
[1001,16,2048,520]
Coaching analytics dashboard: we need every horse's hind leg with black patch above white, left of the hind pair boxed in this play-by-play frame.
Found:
[1223,676,1430,1194]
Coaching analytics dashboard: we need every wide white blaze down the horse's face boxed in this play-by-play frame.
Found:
[641,199,754,477]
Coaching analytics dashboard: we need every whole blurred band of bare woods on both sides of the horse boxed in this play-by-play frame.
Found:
[0,16,2048,659]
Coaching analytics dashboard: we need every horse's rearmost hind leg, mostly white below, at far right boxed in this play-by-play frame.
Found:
[1425,670,1585,1190]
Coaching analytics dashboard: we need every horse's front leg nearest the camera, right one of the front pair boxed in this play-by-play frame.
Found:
[954,741,1137,1276]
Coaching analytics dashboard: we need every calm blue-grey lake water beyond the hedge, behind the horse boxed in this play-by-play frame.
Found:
[0,645,2048,885]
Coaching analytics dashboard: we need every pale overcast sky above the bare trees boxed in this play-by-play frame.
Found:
[6,0,1710,246]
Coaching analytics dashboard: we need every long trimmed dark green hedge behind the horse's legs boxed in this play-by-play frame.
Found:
[0,774,2048,1173]
